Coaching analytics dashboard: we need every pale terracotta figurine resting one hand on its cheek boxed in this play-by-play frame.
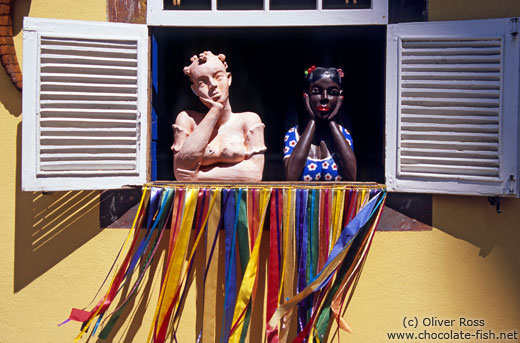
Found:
[172,51,266,182]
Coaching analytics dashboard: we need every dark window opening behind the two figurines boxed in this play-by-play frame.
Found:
[152,26,386,183]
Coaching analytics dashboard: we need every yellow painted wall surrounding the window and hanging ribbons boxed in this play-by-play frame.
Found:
[0,0,520,343]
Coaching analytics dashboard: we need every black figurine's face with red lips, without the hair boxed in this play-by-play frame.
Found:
[309,77,342,119]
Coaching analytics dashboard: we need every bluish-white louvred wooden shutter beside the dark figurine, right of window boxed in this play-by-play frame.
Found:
[385,18,520,195]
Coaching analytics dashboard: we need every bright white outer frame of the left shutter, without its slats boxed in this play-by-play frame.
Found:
[22,18,149,191]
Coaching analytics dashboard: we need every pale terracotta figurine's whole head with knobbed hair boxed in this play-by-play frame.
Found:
[184,51,231,103]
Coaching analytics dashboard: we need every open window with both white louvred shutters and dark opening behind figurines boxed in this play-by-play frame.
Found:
[22,13,520,195]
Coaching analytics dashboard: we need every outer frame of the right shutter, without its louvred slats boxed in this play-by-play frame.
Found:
[385,19,520,196]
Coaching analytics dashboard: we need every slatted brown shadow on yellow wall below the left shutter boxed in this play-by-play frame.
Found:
[13,123,101,293]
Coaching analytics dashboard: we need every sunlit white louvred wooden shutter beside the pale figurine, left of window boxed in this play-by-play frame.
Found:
[22,18,148,191]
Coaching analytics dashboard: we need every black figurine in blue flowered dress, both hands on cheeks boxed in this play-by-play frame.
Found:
[284,66,356,181]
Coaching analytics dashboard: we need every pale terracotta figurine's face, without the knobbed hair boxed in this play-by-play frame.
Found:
[191,58,231,103]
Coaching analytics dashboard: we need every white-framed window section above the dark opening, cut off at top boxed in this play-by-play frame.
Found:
[147,0,388,27]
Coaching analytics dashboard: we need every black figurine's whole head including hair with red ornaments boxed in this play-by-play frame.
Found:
[305,66,344,120]
